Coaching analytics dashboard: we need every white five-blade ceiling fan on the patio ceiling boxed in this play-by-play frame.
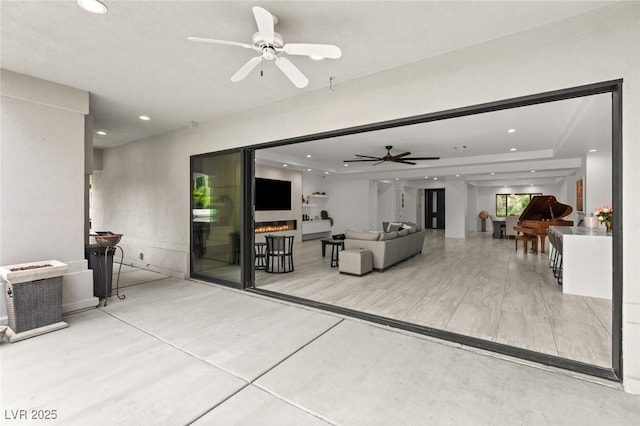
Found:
[187,6,342,89]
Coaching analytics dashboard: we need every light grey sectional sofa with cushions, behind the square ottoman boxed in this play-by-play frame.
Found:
[344,227,426,271]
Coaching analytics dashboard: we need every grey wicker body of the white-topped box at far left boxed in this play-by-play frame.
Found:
[4,276,62,333]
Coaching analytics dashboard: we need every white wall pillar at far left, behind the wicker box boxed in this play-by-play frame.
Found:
[0,70,98,323]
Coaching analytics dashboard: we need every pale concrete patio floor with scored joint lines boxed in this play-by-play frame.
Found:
[0,278,640,426]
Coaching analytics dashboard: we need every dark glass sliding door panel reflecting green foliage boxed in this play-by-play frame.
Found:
[191,152,242,284]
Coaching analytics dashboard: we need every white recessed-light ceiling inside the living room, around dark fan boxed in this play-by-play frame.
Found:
[256,94,612,186]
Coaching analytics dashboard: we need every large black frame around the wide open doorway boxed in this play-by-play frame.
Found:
[242,79,623,381]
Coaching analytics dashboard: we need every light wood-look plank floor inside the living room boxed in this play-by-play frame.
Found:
[256,230,612,368]
